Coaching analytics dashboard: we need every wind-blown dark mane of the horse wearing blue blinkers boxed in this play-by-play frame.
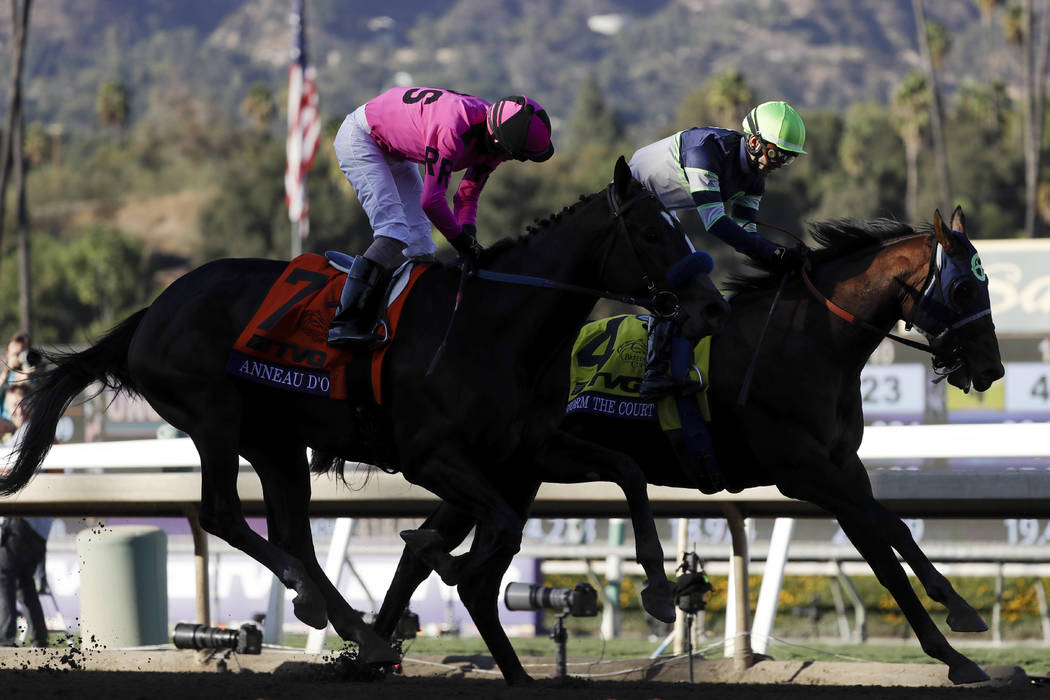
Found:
[722,218,929,293]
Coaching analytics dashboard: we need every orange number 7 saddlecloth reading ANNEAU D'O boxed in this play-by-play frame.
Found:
[226,253,429,404]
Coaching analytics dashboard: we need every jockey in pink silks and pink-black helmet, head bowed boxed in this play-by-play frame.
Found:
[329,87,554,345]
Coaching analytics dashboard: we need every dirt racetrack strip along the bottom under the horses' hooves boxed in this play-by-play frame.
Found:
[0,649,1037,700]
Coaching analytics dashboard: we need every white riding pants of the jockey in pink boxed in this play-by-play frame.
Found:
[333,105,438,258]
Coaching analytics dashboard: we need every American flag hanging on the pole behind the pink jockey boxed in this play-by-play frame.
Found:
[285,0,321,238]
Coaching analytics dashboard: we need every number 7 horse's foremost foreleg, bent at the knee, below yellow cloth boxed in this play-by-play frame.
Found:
[537,431,675,622]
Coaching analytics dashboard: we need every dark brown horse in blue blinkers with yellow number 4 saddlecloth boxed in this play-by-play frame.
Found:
[376,209,1003,683]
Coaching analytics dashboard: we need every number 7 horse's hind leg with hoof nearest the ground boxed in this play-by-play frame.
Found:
[243,440,399,665]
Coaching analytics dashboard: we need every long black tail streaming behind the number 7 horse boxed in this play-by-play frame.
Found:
[0,309,147,495]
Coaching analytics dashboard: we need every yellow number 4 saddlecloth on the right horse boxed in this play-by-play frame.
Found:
[565,315,723,493]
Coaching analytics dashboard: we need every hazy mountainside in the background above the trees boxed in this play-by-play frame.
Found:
[0,0,1020,140]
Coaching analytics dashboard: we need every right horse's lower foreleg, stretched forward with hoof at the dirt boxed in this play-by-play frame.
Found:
[778,484,988,683]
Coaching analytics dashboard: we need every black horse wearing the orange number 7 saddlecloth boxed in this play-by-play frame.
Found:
[0,158,728,676]
